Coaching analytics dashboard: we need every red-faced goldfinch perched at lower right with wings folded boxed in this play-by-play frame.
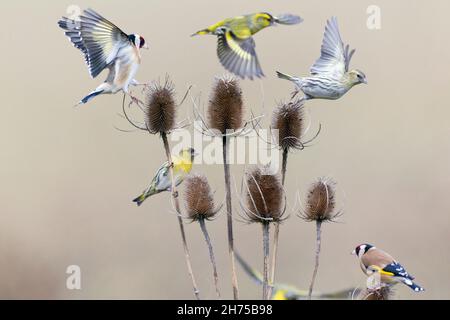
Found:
[352,243,424,292]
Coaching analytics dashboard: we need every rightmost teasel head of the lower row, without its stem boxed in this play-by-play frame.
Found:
[300,177,341,222]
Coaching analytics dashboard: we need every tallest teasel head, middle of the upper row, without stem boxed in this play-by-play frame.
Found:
[208,76,244,134]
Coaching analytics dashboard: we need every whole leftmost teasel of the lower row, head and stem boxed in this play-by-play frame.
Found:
[184,174,221,299]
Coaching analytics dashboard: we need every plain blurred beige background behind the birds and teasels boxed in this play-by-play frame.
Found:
[0,0,450,299]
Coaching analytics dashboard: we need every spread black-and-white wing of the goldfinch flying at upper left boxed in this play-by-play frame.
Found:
[58,9,131,78]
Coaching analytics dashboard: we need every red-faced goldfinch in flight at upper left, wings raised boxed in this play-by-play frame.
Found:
[58,9,148,104]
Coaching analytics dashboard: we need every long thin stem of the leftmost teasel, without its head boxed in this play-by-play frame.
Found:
[161,132,200,300]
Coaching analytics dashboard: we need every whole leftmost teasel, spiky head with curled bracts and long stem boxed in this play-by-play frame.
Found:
[122,76,200,299]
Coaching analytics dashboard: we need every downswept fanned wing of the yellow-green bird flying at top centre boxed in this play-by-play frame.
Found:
[216,28,264,79]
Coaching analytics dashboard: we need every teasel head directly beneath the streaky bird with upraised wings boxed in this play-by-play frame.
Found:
[272,99,305,150]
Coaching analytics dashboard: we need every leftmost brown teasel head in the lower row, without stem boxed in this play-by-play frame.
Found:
[184,174,220,221]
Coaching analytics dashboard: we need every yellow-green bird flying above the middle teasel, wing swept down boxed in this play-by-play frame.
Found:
[193,12,302,79]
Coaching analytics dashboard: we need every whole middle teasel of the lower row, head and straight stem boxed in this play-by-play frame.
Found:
[241,166,286,300]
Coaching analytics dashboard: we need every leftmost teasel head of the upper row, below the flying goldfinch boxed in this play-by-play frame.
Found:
[144,77,176,134]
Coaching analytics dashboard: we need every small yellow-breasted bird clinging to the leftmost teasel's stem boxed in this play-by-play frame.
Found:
[133,148,196,206]
